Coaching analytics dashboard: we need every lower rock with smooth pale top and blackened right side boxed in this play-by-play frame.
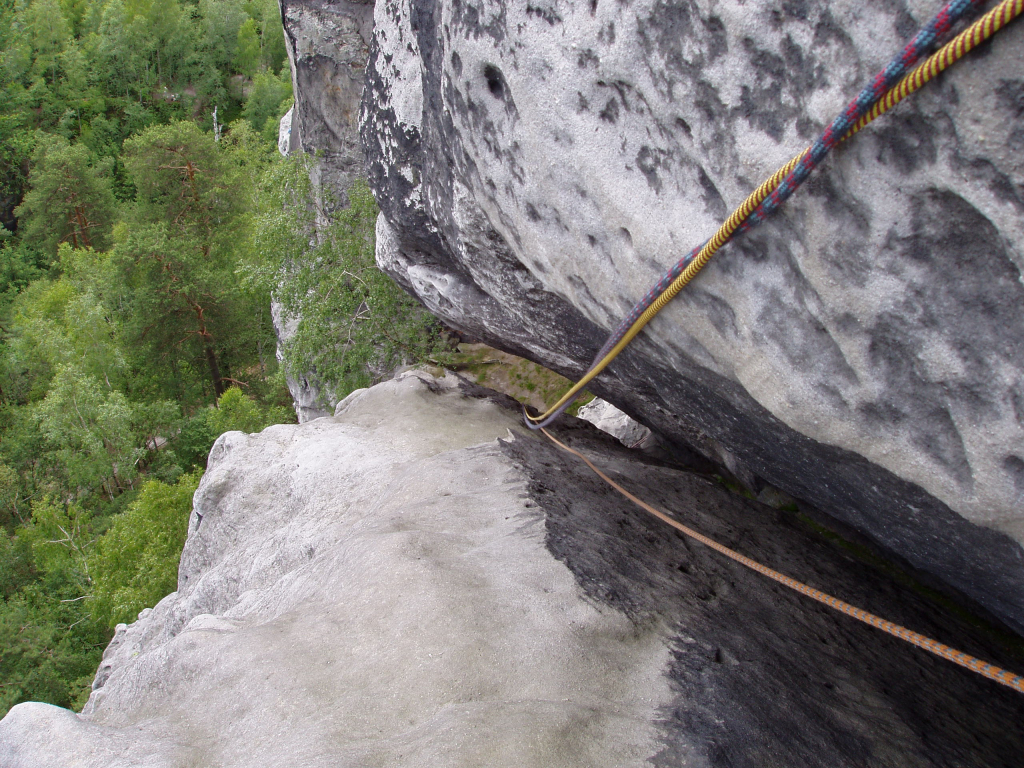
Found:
[0,373,1024,768]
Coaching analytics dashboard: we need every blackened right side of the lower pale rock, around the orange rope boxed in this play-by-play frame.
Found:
[501,419,1024,768]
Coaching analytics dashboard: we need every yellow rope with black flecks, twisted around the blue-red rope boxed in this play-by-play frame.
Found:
[526,0,1024,423]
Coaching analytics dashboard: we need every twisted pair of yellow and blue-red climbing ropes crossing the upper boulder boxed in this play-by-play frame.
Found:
[526,0,1024,429]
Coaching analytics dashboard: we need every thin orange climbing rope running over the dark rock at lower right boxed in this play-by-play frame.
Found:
[541,428,1024,693]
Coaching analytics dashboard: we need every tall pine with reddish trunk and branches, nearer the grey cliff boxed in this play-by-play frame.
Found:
[115,122,249,396]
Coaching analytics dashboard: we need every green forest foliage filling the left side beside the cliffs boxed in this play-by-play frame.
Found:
[0,0,448,715]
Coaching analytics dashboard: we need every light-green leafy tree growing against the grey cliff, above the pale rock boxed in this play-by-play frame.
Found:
[245,158,443,397]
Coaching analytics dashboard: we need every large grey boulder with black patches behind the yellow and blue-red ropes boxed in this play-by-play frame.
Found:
[361,0,1024,632]
